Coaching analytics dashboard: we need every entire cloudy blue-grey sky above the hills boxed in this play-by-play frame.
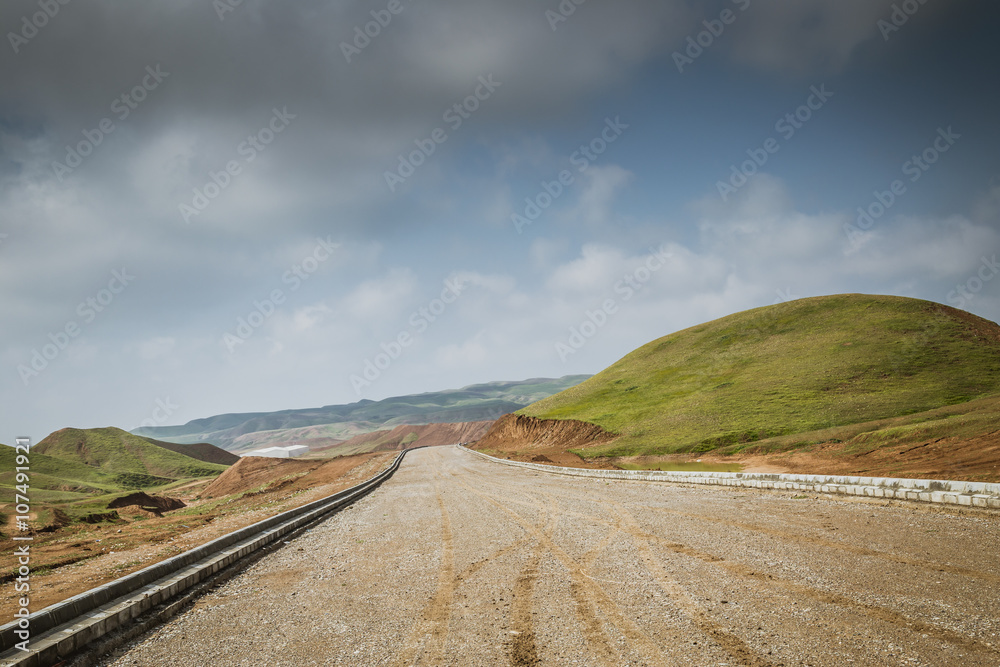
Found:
[0,0,1000,442]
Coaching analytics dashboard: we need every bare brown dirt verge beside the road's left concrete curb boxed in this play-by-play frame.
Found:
[0,452,395,611]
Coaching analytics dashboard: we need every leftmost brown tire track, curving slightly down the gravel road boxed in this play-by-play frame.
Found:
[393,482,458,667]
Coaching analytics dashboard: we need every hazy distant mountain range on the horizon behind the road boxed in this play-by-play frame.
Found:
[132,375,590,452]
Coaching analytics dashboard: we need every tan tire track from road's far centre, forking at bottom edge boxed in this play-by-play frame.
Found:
[451,471,670,667]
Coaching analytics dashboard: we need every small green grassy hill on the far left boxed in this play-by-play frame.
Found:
[32,427,226,488]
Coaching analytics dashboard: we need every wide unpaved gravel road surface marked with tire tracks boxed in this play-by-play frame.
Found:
[103,447,1000,667]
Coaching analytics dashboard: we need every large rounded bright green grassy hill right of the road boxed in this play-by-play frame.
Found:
[518,294,1000,456]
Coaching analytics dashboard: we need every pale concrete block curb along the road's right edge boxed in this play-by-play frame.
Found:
[459,445,1000,509]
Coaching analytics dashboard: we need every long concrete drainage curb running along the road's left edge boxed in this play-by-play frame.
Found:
[0,447,420,667]
